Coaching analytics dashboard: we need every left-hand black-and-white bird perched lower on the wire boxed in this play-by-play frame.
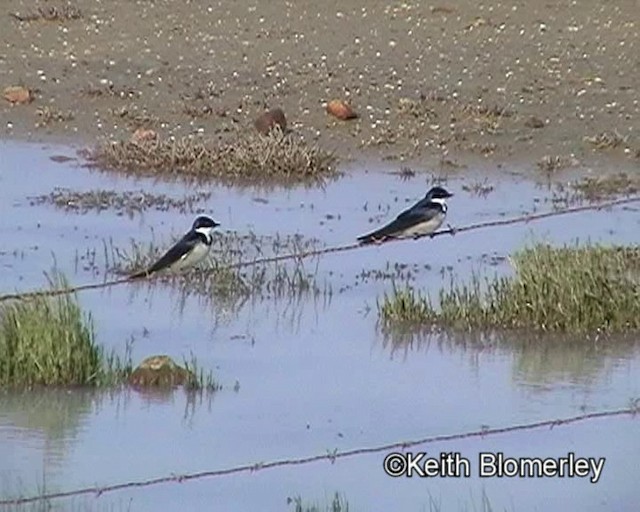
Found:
[129,216,220,279]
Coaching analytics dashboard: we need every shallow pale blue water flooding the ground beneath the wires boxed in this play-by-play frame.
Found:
[0,138,640,510]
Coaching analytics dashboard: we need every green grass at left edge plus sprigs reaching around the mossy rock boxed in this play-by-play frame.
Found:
[0,273,220,391]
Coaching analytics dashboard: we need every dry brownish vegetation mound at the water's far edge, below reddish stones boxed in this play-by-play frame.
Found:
[84,130,338,184]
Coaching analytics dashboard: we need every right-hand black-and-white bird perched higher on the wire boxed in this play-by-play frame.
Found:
[358,186,453,244]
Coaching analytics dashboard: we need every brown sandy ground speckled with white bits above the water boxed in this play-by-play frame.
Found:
[0,0,640,170]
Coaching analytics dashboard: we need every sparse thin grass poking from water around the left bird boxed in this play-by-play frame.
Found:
[105,232,331,304]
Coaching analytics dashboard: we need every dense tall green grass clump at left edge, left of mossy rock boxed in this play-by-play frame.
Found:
[0,277,130,387]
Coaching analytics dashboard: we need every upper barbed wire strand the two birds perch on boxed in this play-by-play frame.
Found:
[0,196,640,302]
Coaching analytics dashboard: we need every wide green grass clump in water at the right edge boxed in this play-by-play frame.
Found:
[378,244,640,332]
